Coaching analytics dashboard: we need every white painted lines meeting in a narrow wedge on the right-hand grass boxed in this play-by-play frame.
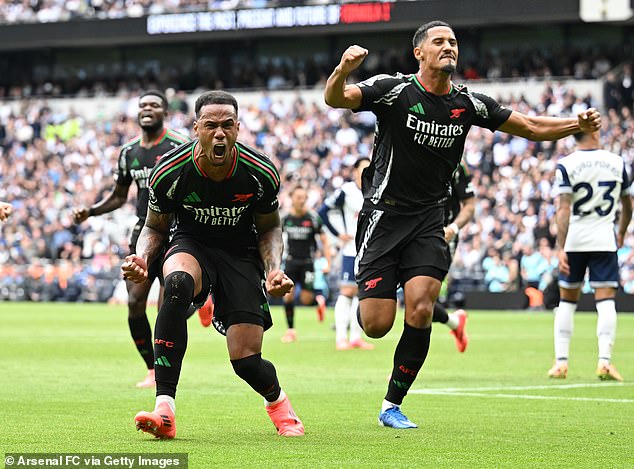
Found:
[408,383,634,404]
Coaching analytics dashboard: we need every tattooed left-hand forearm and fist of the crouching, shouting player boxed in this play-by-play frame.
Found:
[121,208,173,283]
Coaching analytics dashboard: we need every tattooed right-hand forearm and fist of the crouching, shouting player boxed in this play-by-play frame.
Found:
[255,210,293,296]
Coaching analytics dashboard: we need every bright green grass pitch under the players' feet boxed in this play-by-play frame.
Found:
[0,303,634,468]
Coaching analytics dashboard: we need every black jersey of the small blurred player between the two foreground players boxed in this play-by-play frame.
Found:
[282,210,323,260]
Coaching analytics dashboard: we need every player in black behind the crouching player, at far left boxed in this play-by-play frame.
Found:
[73,90,209,388]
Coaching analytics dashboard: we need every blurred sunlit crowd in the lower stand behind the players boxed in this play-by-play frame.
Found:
[0,80,634,301]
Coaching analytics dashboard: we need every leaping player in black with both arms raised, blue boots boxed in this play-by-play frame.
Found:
[324,21,601,428]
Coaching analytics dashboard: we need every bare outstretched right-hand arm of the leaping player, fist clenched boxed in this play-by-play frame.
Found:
[498,108,601,141]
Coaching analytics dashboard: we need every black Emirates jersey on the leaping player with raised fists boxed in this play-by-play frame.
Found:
[355,73,511,213]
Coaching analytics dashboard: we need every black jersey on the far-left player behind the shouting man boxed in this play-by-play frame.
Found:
[116,129,189,220]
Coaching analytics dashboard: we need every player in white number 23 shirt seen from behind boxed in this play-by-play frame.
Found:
[548,132,632,381]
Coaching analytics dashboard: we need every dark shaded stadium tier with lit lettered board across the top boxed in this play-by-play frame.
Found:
[0,0,634,96]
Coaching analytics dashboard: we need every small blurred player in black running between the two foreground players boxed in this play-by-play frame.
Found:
[282,185,332,343]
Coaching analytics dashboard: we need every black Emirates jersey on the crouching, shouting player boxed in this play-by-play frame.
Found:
[149,139,280,248]
